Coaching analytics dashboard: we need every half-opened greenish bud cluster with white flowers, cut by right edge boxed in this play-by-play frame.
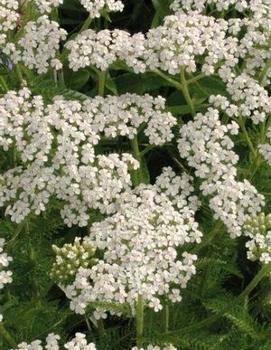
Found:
[243,213,271,264]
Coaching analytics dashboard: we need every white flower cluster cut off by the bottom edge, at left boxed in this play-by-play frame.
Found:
[13,333,96,350]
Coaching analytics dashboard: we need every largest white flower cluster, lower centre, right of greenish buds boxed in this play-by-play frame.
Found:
[62,169,202,314]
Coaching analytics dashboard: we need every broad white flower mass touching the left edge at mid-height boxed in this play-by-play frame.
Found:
[0,89,138,226]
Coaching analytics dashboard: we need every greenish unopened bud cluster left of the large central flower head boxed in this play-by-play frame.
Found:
[50,237,96,286]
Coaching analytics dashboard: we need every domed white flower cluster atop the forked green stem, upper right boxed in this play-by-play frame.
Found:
[145,12,237,75]
